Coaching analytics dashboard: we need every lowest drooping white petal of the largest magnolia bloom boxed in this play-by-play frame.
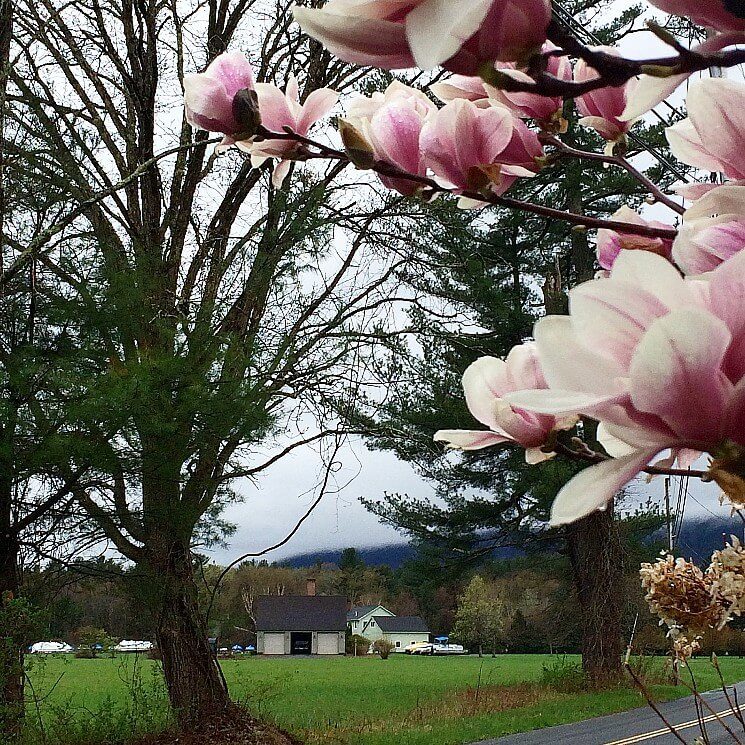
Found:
[551,450,659,527]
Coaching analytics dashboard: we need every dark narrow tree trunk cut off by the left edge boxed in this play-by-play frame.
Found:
[0,531,24,740]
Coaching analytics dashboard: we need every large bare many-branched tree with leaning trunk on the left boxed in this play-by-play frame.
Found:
[2,0,418,725]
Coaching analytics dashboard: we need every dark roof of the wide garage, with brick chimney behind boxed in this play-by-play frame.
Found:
[254,595,347,631]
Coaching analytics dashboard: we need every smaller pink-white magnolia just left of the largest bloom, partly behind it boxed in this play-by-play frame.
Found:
[435,343,577,463]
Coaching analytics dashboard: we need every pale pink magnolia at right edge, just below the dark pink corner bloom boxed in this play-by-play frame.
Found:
[666,78,745,179]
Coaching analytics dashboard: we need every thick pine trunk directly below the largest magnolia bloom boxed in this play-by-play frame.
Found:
[567,502,623,686]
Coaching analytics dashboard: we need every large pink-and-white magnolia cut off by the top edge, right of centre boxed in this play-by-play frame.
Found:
[293,0,551,75]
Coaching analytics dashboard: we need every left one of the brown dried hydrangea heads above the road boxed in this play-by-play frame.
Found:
[639,556,727,633]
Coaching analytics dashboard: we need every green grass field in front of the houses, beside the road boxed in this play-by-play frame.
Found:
[23,655,745,745]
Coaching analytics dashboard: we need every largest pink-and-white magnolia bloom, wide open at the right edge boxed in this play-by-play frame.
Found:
[505,251,745,525]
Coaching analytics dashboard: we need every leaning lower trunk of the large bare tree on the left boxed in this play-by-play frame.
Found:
[148,541,230,729]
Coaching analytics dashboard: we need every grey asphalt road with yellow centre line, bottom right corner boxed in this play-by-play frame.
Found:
[474,686,745,745]
